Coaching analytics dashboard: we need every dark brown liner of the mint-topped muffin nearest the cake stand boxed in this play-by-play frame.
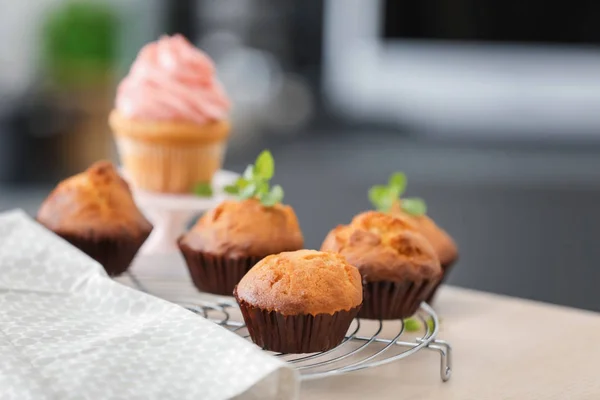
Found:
[178,240,263,296]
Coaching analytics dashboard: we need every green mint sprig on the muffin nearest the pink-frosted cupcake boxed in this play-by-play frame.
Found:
[224,150,284,207]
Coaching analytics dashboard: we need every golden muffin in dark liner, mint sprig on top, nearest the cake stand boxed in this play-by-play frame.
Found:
[178,198,304,296]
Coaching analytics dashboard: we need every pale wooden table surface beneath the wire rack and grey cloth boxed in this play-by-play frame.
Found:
[120,255,600,400]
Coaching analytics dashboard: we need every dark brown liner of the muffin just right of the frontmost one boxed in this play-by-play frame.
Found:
[358,277,441,319]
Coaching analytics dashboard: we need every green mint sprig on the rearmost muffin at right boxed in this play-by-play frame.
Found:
[369,172,427,216]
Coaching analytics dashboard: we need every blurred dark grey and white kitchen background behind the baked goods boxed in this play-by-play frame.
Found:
[0,0,600,311]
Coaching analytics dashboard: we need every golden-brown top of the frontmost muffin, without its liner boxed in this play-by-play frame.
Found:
[236,250,363,315]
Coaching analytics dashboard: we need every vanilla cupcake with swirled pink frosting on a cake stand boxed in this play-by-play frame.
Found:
[109,35,230,193]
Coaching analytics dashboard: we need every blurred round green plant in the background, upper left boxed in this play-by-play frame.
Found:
[42,0,119,85]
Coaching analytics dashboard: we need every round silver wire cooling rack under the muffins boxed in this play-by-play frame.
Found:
[128,273,452,382]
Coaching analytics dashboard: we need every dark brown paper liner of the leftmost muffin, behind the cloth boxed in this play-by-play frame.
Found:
[59,232,150,276]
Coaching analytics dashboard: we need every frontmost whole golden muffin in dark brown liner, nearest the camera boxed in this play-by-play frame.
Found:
[234,250,362,353]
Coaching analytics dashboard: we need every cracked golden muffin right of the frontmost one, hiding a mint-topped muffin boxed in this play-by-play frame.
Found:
[321,211,442,319]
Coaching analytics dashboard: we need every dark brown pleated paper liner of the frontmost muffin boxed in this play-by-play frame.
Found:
[234,291,360,353]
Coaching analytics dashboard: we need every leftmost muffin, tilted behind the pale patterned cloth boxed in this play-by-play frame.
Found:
[37,161,152,276]
